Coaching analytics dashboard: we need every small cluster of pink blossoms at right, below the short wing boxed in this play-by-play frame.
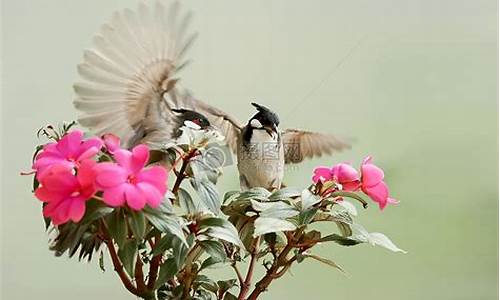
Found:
[312,156,398,209]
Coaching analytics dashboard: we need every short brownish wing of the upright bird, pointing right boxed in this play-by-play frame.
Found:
[282,129,351,164]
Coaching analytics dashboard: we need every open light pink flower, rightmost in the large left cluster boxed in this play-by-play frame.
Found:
[96,145,167,210]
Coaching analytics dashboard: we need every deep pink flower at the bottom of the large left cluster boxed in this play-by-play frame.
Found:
[35,159,96,225]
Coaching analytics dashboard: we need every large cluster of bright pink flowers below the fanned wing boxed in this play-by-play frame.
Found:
[33,130,167,225]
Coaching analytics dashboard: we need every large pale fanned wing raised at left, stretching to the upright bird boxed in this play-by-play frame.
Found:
[74,1,239,147]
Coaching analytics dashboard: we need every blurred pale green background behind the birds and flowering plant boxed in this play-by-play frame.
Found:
[1,0,498,300]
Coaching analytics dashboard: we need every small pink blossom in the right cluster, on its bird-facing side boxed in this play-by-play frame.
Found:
[312,163,359,192]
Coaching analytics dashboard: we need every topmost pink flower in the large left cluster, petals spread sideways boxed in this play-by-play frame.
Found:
[33,130,102,179]
